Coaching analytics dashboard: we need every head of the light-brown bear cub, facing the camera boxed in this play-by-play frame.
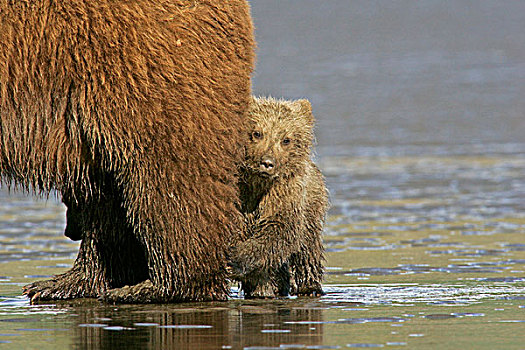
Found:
[245,97,314,178]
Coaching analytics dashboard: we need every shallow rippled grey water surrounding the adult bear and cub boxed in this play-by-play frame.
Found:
[0,0,525,349]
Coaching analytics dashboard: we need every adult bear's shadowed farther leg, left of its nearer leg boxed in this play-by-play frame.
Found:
[24,176,148,302]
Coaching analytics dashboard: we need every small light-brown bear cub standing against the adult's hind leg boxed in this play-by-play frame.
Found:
[231,98,328,297]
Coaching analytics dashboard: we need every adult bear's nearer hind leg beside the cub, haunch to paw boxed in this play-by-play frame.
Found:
[101,0,254,302]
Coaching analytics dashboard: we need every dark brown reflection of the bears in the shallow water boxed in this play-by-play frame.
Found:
[0,301,323,349]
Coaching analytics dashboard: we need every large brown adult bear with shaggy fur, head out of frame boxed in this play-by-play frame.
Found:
[0,0,254,302]
